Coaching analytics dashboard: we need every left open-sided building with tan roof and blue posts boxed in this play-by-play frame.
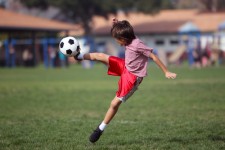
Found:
[0,8,80,67]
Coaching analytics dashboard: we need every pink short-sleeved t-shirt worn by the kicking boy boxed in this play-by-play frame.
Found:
[125,38,153,77]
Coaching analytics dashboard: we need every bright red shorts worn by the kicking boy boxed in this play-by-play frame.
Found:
[108,56,143,102]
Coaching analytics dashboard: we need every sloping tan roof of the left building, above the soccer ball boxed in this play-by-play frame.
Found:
[0,8,80,31]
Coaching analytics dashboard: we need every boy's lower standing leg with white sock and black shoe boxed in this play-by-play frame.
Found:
[89,97,122,143]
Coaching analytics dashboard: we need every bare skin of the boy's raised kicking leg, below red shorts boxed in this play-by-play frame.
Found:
[83,53,109,65]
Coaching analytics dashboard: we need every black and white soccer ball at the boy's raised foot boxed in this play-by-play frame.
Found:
[59,36,80,57]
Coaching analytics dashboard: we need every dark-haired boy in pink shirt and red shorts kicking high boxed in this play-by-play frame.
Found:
[74,19,176,143]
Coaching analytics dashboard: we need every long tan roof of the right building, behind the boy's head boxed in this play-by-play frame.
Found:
[93,9,225,35]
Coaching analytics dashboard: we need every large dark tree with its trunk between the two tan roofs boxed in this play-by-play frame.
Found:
[21,0,172,34]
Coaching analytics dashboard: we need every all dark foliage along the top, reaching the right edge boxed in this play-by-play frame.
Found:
[21,0,225,34]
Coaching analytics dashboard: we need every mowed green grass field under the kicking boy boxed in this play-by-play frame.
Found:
[0,63,225,150]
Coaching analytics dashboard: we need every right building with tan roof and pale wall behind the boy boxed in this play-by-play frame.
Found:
[89,9,225,65]
